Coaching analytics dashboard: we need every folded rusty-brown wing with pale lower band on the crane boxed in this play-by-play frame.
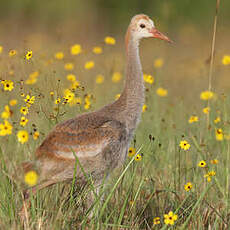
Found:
[36,115,126,160]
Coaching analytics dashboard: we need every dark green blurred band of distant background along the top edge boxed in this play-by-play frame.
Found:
[0,0,230,31]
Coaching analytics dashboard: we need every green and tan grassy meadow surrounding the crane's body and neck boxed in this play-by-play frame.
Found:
[0,15,230,229]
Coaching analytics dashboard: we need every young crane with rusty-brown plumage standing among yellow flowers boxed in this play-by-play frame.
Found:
[21,14,171,211]
